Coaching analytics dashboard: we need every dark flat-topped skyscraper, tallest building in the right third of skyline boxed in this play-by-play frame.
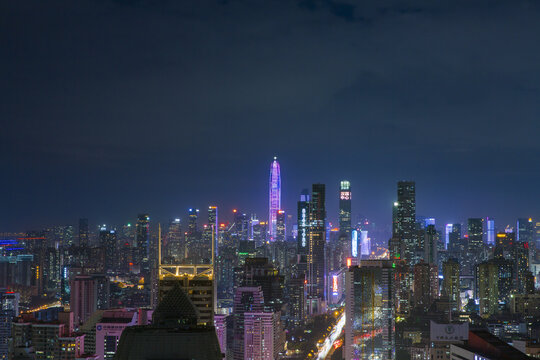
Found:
[396,181,418,266]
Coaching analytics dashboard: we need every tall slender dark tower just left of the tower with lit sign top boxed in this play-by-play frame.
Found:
[307,184,326,313]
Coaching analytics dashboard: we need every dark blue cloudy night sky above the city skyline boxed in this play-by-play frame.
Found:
[0,0,540,231]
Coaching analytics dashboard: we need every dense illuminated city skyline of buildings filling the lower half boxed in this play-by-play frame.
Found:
[0,158,540,360]
